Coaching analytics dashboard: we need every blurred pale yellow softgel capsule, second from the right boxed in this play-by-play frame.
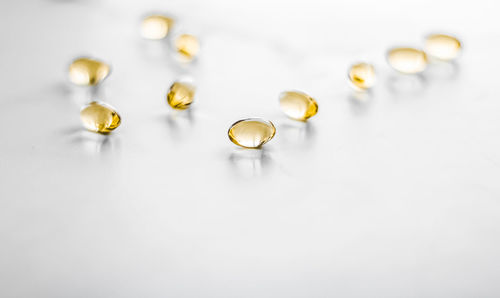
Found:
[387,48,428,74]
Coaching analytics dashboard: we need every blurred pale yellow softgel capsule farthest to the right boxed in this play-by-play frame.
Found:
[424,34,462,61]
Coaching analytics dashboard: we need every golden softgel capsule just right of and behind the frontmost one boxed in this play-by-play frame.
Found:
[280,91,318,121]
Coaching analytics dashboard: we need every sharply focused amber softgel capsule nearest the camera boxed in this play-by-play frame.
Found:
[227,118,276,148]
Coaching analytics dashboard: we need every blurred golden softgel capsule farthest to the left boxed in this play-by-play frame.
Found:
[69,58,110,86]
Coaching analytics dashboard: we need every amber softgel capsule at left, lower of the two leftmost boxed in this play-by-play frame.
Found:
[80,101,121,133]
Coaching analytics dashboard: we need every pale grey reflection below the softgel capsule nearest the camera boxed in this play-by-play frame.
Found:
[227,147,274,177]
